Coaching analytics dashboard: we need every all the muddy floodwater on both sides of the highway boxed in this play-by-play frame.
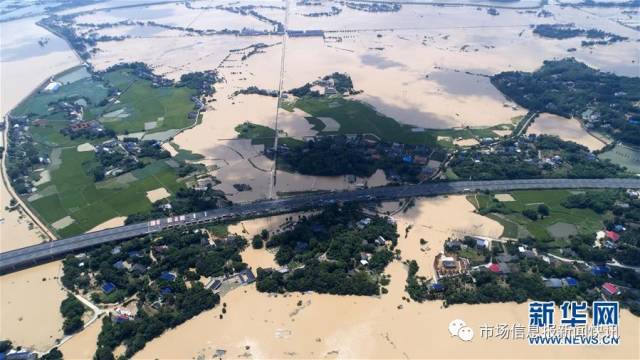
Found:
[0,0,640,358]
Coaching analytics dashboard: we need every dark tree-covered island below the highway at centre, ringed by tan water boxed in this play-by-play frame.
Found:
[257,204,398,295]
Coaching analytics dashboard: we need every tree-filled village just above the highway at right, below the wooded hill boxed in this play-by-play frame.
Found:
[450,135,625,180]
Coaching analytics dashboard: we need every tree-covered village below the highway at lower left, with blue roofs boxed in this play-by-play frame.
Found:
[61,229,247,358]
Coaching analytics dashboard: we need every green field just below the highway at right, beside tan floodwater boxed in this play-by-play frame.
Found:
[469,190,605,242]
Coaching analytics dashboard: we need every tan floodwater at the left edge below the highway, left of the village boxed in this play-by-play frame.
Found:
[0,262,66,351]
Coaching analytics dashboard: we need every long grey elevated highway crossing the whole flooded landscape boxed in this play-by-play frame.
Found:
[0,179,640,274]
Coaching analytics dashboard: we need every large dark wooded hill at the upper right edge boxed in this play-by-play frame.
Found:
[491,58,640,145]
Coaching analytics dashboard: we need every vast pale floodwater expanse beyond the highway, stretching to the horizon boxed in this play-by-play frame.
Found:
[72,1,638,201]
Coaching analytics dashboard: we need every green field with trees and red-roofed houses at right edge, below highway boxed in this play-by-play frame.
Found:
[472,189,640,266]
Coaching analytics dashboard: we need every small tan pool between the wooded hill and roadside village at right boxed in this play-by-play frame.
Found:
[527,113,607,151]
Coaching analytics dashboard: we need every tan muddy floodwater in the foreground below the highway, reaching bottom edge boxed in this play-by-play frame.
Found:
[135,196,640,359]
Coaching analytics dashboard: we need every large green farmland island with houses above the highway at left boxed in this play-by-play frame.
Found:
[7,63,216,236]
